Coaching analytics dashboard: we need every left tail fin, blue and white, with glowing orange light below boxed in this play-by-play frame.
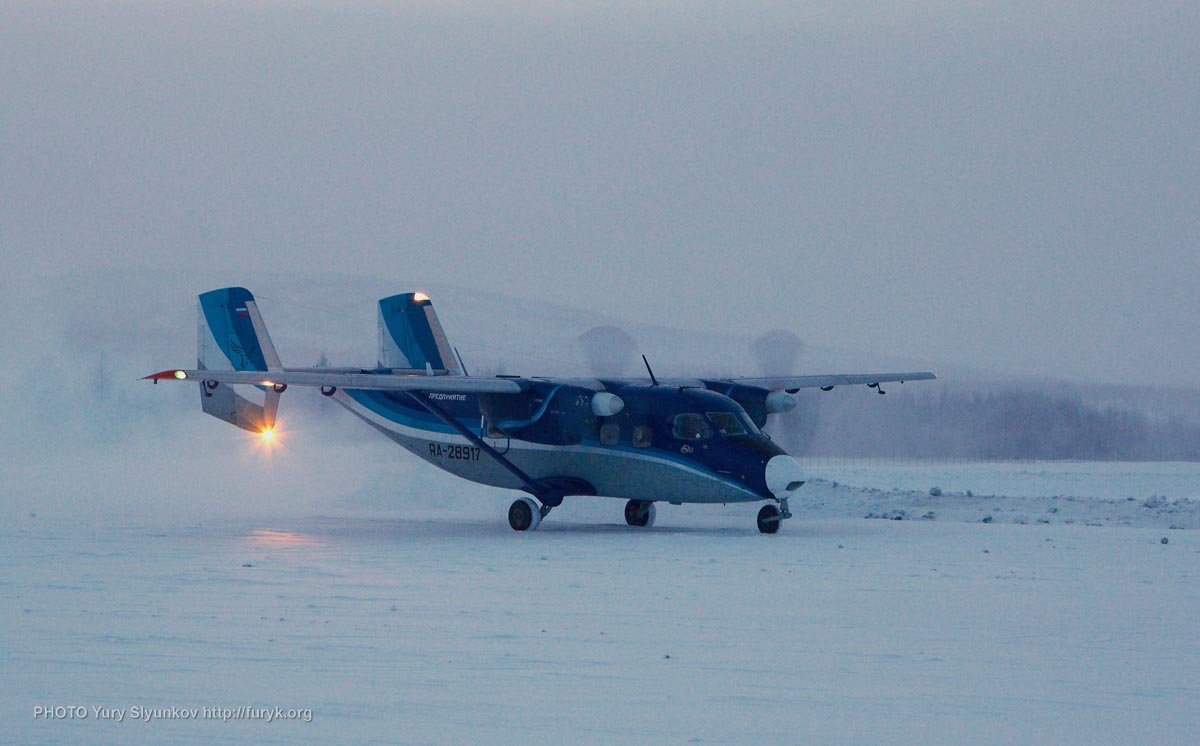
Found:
[197,288,283,433]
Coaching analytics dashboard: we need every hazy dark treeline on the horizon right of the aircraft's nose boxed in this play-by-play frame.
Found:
[774,387,1200,461]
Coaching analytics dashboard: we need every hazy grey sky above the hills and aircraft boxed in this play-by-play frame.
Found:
[0,0,1200,385]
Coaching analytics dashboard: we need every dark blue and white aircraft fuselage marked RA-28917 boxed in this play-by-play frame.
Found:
[334,381,790,503]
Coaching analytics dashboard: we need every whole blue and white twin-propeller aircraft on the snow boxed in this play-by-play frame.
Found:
[146,288,936,534]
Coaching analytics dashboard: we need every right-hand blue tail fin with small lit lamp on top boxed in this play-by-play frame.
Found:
[379,293,463,375]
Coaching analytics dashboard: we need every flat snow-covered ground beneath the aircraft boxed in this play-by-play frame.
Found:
[0,459,1200,744]
